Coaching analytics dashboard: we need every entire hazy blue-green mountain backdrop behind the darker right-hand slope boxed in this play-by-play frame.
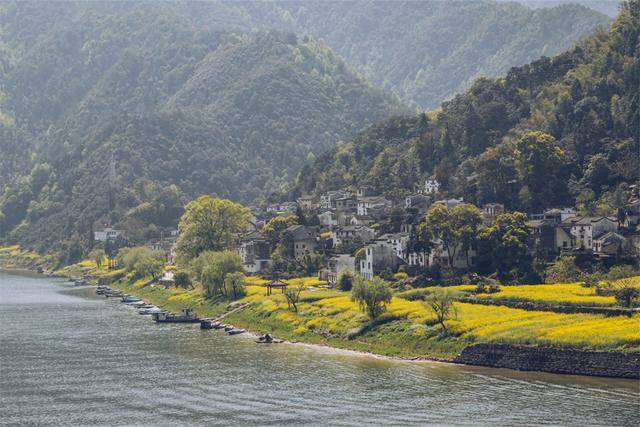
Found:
[0,1,620,258]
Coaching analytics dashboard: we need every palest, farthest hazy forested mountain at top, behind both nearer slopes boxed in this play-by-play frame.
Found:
[277,0,607,109]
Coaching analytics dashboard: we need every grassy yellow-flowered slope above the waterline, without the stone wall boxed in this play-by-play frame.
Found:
[75,263,640,359]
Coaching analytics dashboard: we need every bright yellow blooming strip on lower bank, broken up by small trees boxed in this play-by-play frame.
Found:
[242,285,640,349]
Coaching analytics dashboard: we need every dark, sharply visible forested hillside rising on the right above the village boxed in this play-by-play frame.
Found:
[292,0,640,214]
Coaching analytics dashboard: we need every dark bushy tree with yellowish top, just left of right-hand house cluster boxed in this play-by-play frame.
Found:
[478,212,531,279]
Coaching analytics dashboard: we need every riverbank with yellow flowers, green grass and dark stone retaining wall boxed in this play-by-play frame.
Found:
[89,270,640,378]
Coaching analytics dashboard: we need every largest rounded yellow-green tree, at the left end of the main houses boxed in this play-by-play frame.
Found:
[176,196,250,262]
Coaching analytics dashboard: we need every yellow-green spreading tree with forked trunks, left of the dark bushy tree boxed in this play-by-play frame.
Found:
[418,203,482,267]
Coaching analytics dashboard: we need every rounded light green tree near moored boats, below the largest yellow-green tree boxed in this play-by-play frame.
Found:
[191,251,243,297]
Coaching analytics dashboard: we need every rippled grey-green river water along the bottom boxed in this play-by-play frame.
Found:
[0,273,640,426]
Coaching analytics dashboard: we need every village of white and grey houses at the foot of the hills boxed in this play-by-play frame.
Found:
[94,179,640,286]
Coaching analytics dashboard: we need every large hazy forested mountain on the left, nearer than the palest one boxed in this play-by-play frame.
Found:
[0,3,402,252]
